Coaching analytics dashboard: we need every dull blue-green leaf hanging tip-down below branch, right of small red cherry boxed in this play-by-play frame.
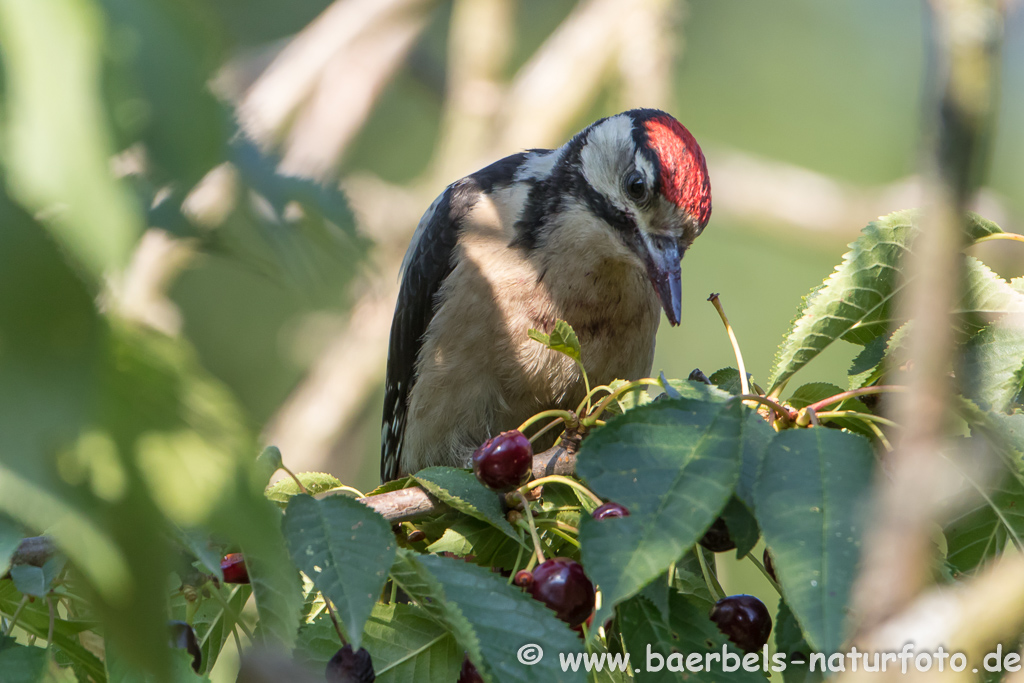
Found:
[284,496,395,648]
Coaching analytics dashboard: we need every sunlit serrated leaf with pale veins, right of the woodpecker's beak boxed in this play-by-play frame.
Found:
[768,211,999,392]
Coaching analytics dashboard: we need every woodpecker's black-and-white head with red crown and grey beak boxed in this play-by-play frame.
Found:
[562,110,711,325]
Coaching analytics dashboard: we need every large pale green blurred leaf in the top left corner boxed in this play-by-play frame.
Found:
[0,0,142,280]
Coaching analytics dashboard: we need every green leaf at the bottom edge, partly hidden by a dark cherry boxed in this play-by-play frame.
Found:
[297,604,463,683]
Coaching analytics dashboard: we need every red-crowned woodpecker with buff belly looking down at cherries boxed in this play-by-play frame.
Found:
[381,110,711,481]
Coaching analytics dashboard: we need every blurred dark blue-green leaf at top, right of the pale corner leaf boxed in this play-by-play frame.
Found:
[99,0,228,187]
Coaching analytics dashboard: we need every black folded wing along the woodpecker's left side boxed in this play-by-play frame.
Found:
[381,153,528,481]
